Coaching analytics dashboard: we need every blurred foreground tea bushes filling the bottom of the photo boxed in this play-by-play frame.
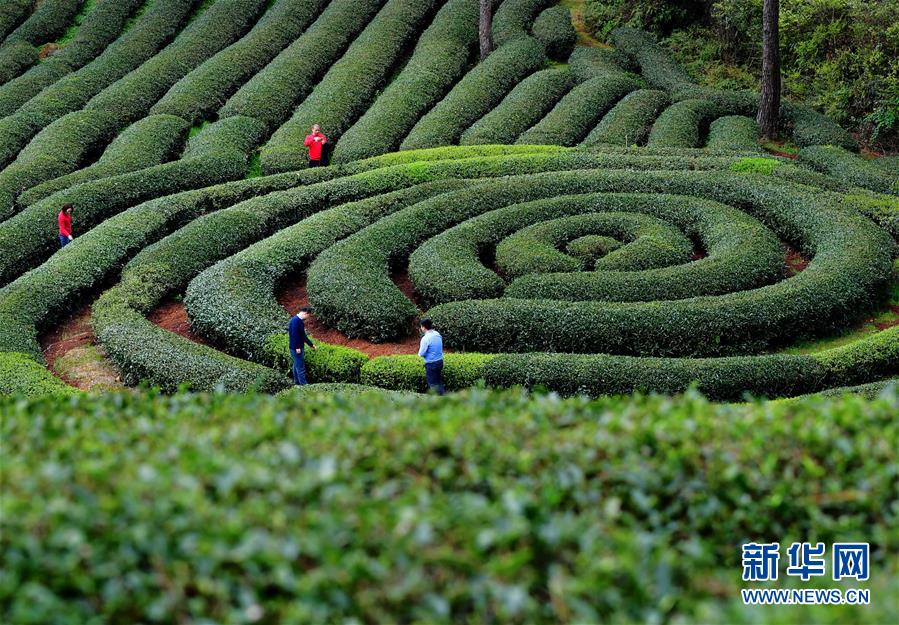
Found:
[0,387,899,623]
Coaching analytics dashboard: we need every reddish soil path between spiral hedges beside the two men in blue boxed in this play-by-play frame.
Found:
[275,272,428,358]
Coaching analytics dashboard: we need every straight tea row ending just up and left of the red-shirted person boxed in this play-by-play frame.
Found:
[218,0,385,133]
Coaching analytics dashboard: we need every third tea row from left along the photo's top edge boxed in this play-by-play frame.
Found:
[0,0,145,117]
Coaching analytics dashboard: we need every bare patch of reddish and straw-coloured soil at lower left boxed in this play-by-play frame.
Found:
[39,306,125,391]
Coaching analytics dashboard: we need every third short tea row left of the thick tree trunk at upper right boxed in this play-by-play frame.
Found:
[581,89,668,147]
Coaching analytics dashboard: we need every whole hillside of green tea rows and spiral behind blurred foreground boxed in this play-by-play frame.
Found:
[0,0,899,399]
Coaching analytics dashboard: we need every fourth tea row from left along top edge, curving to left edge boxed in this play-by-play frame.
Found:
[0,0,200,167]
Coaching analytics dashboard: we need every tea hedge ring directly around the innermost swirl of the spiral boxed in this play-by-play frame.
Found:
[409,194,783,302]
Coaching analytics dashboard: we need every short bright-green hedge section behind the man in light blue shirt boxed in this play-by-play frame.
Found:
[360,353,493,393]
